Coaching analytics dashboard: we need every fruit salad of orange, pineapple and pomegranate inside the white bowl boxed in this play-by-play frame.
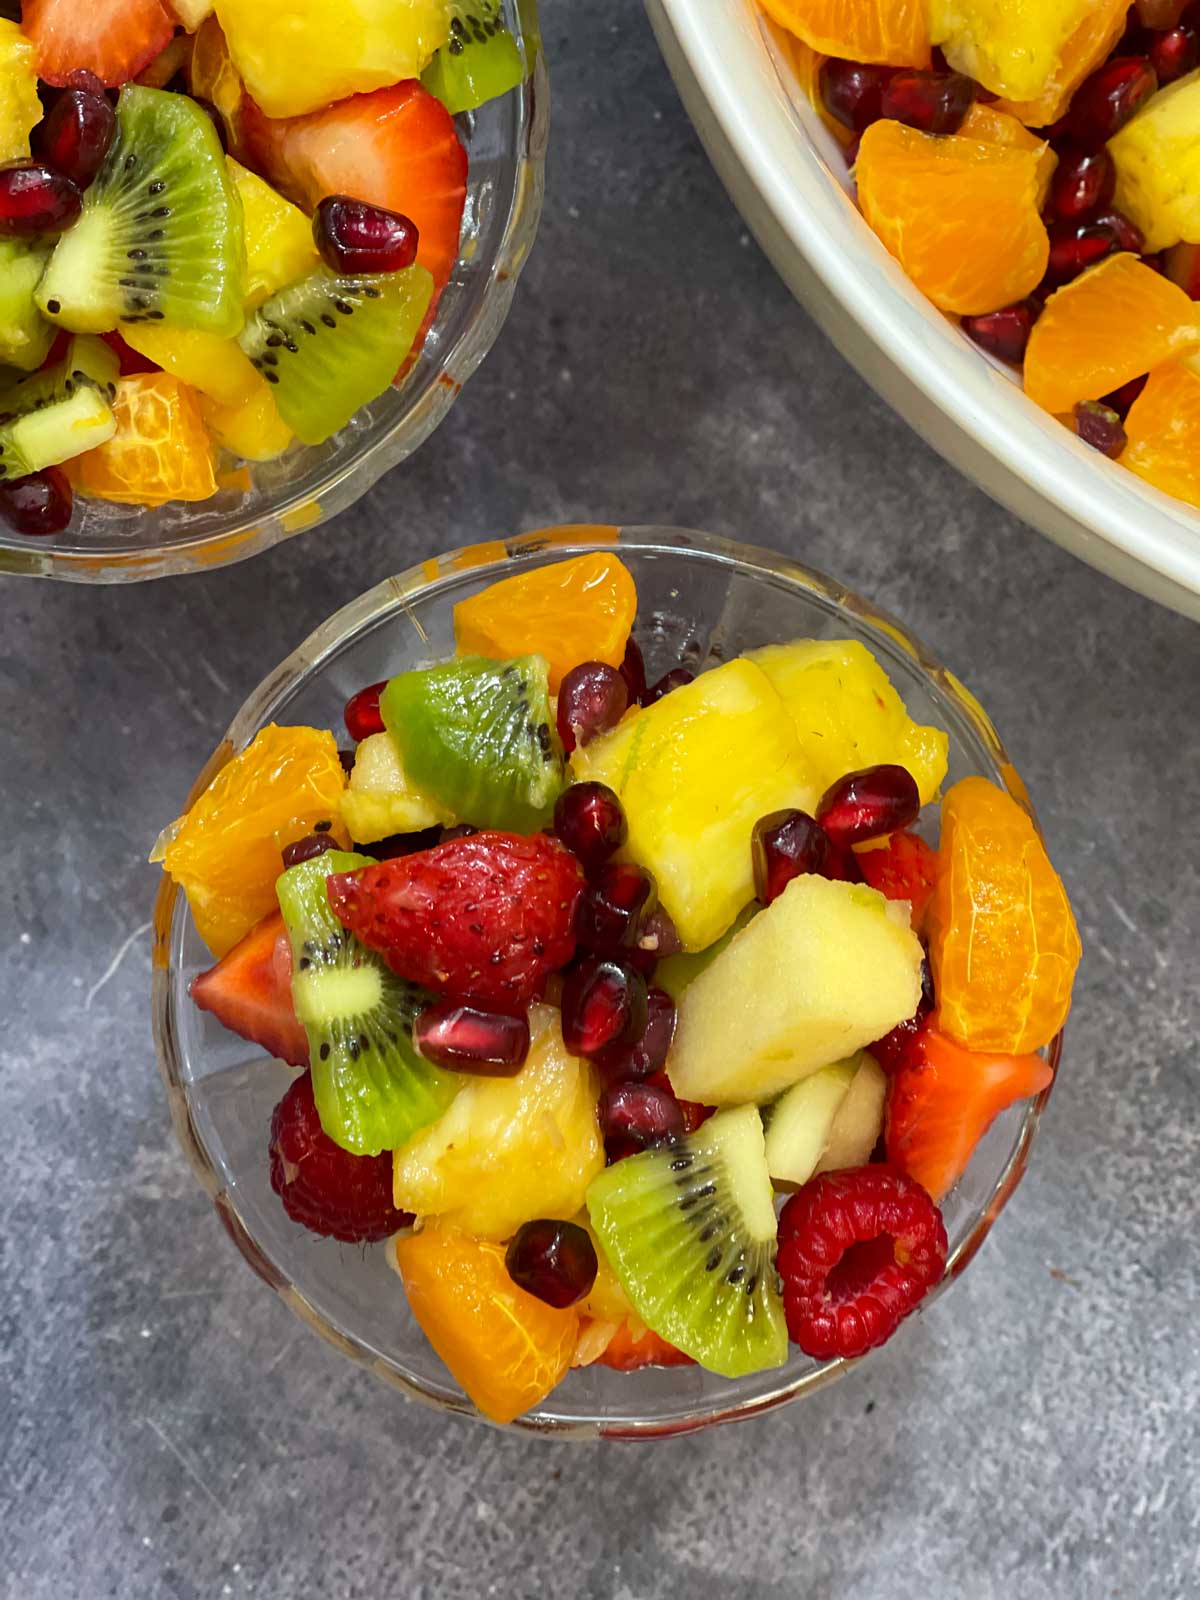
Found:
[760,0,1200,506]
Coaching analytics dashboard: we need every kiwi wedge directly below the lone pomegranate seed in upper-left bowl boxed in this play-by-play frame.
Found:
[240,267,434,445]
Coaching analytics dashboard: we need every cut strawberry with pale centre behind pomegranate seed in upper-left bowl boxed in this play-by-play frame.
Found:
[242,78,467,291]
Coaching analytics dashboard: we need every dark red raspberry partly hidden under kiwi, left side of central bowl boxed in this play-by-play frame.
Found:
[270,1072,413,1245]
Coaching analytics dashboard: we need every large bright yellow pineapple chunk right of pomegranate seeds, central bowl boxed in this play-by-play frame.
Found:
[571,661,819,950]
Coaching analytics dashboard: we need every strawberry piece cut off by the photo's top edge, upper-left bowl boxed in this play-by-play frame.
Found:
[21,0,174,88]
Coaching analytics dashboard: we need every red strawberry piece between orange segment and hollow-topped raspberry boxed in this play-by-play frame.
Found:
[885,1016,1054,1200]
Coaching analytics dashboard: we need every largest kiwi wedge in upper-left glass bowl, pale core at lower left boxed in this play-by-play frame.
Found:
[37,85,246,338]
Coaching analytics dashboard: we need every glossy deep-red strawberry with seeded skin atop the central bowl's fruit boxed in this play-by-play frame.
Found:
[328,832,584,1011]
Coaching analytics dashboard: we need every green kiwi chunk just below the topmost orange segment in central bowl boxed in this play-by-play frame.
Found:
[379,656,566,834]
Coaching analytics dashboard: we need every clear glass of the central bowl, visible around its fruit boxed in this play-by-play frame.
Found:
[154,526,1061,1438]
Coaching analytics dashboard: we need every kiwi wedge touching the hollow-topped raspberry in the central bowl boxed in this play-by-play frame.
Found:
[587,1106,787,1378]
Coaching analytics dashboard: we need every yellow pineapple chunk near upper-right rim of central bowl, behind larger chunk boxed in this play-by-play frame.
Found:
[749,638,950,805]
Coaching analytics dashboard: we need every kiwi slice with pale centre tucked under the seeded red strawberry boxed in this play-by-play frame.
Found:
[275,850,464,1155]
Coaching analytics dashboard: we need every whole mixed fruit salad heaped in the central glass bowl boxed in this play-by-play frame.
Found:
[152,550,1080,1422]
